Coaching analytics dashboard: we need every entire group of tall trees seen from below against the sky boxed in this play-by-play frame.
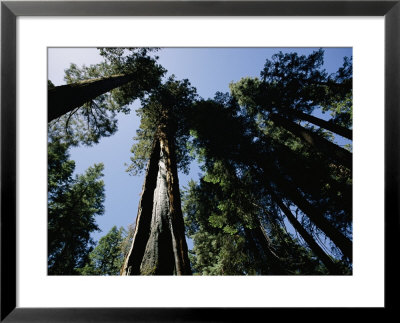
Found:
[48,48,353,275]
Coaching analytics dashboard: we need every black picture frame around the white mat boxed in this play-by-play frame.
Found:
[0,0,400,322]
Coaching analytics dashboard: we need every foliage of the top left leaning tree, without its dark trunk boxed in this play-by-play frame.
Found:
[49,48,165,146]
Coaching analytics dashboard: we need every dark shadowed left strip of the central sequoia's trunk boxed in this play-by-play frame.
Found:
[121,139,160,275]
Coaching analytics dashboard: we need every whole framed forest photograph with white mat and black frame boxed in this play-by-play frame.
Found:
[1,0,400,322]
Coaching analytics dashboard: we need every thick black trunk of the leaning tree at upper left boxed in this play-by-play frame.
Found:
[47,74,135,122]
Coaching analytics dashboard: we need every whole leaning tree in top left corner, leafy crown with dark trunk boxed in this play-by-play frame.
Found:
[49,48,165,145]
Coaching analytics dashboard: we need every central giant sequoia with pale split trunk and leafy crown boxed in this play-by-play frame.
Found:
[122,78,196,275]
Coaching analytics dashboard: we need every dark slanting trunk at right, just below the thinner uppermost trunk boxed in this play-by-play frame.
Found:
[270,114,352,169]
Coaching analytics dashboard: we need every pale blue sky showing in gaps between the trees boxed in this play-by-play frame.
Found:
[48,48,352,248]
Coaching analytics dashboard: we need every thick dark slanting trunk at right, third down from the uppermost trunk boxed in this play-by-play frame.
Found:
[271,173,352,260]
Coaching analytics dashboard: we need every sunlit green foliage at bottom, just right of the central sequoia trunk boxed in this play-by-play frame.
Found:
[183,177,324,275]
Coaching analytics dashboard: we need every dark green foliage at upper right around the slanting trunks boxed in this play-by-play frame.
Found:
[230,50,352,239]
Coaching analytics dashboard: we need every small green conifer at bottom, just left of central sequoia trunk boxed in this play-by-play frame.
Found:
[79,226,127,276]
